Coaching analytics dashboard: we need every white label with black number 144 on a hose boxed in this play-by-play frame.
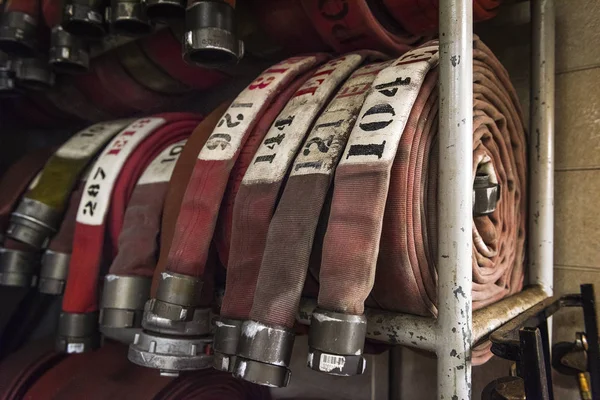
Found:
[242,54,363,185]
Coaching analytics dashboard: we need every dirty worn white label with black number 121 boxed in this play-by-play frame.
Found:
[290,62,390,176]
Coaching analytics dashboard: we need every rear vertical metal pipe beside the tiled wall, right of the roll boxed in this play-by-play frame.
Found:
[529,0,555,296]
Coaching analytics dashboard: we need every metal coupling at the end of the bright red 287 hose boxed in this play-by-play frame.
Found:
[56,311,100,354]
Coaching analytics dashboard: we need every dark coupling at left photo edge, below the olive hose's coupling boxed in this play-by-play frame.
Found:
[0,248,40,287]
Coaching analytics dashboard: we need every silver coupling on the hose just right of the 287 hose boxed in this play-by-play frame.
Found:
[100,275,152,344]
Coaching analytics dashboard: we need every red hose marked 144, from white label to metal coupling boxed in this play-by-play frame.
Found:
[215,53,382,386]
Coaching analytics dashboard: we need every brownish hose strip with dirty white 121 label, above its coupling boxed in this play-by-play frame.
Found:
[232,59,388,384]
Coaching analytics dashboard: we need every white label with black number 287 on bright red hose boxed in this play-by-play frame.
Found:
[77,118,166,225]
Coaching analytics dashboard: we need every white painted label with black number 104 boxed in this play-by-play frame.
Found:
[340,46,439,165]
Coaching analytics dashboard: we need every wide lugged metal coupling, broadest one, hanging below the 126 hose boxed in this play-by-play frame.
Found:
[128,331,213,376]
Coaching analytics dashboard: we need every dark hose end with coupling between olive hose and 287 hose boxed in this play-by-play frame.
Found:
[38,176,87,296]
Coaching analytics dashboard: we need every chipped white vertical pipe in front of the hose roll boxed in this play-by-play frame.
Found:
[437,0,473,399]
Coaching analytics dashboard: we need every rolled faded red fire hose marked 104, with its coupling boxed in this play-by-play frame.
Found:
[308,40,526,375]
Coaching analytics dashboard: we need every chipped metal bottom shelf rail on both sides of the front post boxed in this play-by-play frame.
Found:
[297,286,548,351]
